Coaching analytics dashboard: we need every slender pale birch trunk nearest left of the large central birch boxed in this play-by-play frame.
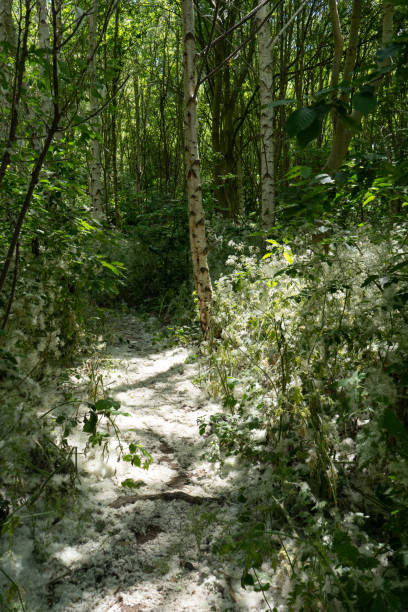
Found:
[88,0,102,216]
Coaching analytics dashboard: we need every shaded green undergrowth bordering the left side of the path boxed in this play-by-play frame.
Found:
[0,215,139,610]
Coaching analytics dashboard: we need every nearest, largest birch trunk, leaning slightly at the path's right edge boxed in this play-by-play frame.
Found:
[182,0,212,336]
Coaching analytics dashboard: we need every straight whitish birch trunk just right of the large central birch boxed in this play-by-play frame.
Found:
[258,4,275,229]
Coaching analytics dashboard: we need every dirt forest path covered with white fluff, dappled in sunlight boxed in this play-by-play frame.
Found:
[47,315,267,612]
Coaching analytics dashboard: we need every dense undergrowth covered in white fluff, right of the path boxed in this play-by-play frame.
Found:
[200,226,408,610]
